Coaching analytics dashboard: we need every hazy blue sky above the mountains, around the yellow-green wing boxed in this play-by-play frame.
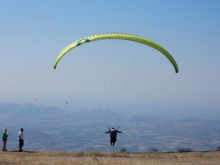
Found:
[0,0,220,117]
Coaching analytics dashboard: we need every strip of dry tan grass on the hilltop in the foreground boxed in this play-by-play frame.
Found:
[0,151,220,165]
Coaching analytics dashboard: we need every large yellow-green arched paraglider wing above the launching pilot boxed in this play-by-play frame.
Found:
[53,33,179,73]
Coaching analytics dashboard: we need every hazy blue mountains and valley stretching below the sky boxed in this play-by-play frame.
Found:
[0,103,220,152]
